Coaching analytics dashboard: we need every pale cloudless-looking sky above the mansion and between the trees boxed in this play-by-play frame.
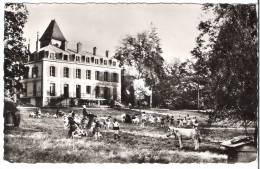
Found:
[24,4,203,63]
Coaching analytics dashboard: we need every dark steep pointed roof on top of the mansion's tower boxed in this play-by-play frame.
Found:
[40,20,66,41]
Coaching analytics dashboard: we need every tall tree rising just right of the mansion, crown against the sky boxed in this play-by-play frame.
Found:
[115,27,164,107]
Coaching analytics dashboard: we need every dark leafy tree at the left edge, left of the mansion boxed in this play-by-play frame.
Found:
[4,3,28,97]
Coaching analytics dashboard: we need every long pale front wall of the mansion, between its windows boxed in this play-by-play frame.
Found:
[43,59,121,105]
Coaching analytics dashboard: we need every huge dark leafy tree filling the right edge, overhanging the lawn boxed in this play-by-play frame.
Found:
[192,4,258,124]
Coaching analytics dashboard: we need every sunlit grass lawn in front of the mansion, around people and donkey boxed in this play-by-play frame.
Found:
[4,109,254,163]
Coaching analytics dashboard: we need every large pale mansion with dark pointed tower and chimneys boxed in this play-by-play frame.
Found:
[20,20,121,106]
